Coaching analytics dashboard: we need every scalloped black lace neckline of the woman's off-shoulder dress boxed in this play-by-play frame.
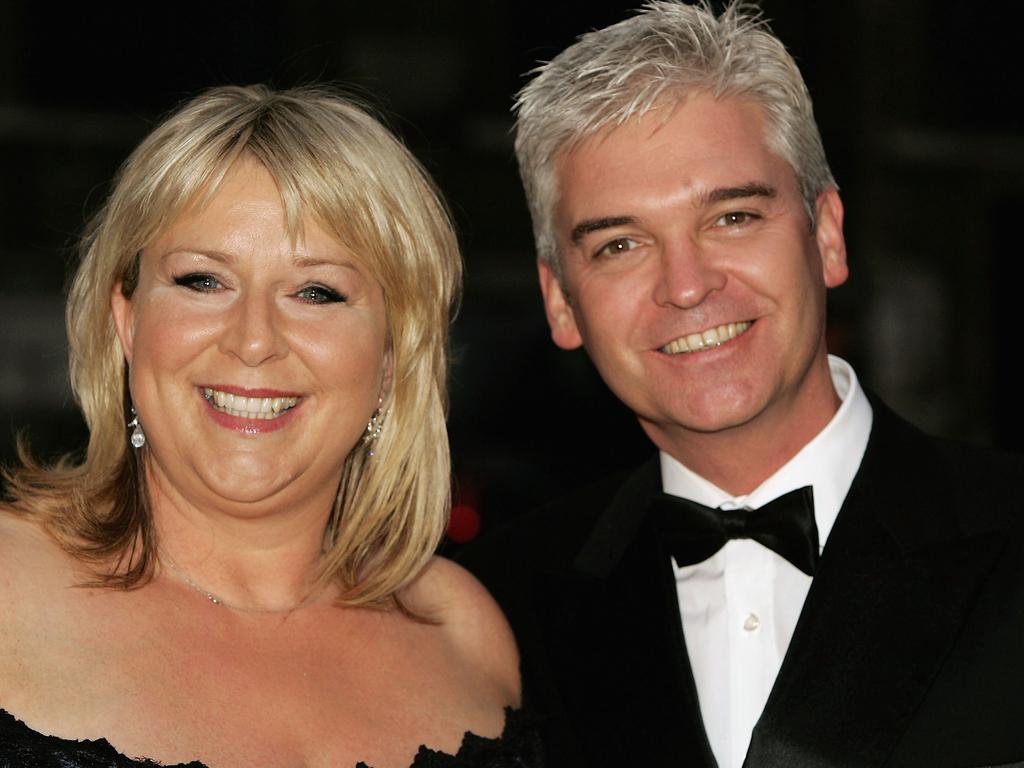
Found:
[0,710,544,768]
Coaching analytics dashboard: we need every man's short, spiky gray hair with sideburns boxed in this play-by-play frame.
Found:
[515,0,836,278]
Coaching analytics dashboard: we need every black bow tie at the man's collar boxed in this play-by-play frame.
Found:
[653,485,818,575]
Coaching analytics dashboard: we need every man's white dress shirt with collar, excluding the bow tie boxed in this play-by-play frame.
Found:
[660,355,871,768]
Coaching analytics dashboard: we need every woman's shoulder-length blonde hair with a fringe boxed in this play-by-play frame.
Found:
[6,85,462,605]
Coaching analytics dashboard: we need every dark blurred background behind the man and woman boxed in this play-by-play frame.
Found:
[0,0,1024,548]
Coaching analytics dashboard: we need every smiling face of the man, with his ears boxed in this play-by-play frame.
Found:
[540,94,847,468]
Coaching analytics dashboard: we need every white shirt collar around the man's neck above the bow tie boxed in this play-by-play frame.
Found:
[660,355,872,547]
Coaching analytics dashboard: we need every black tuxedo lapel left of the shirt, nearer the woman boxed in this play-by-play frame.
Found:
[535,462,715,768]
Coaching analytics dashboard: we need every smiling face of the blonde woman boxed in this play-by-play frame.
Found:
[112,159,390,515]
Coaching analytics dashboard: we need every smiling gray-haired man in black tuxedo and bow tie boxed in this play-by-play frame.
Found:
[464,2,1024,768]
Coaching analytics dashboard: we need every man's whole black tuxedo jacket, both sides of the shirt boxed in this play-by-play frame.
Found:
[462,401,1024,768]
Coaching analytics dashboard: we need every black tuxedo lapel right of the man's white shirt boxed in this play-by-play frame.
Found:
[744,402,1000,768]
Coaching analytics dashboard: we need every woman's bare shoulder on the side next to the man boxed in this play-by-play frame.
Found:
[403,557,520,705]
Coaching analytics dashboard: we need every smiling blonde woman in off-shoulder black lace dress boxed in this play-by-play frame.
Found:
[0,87,536,768]
